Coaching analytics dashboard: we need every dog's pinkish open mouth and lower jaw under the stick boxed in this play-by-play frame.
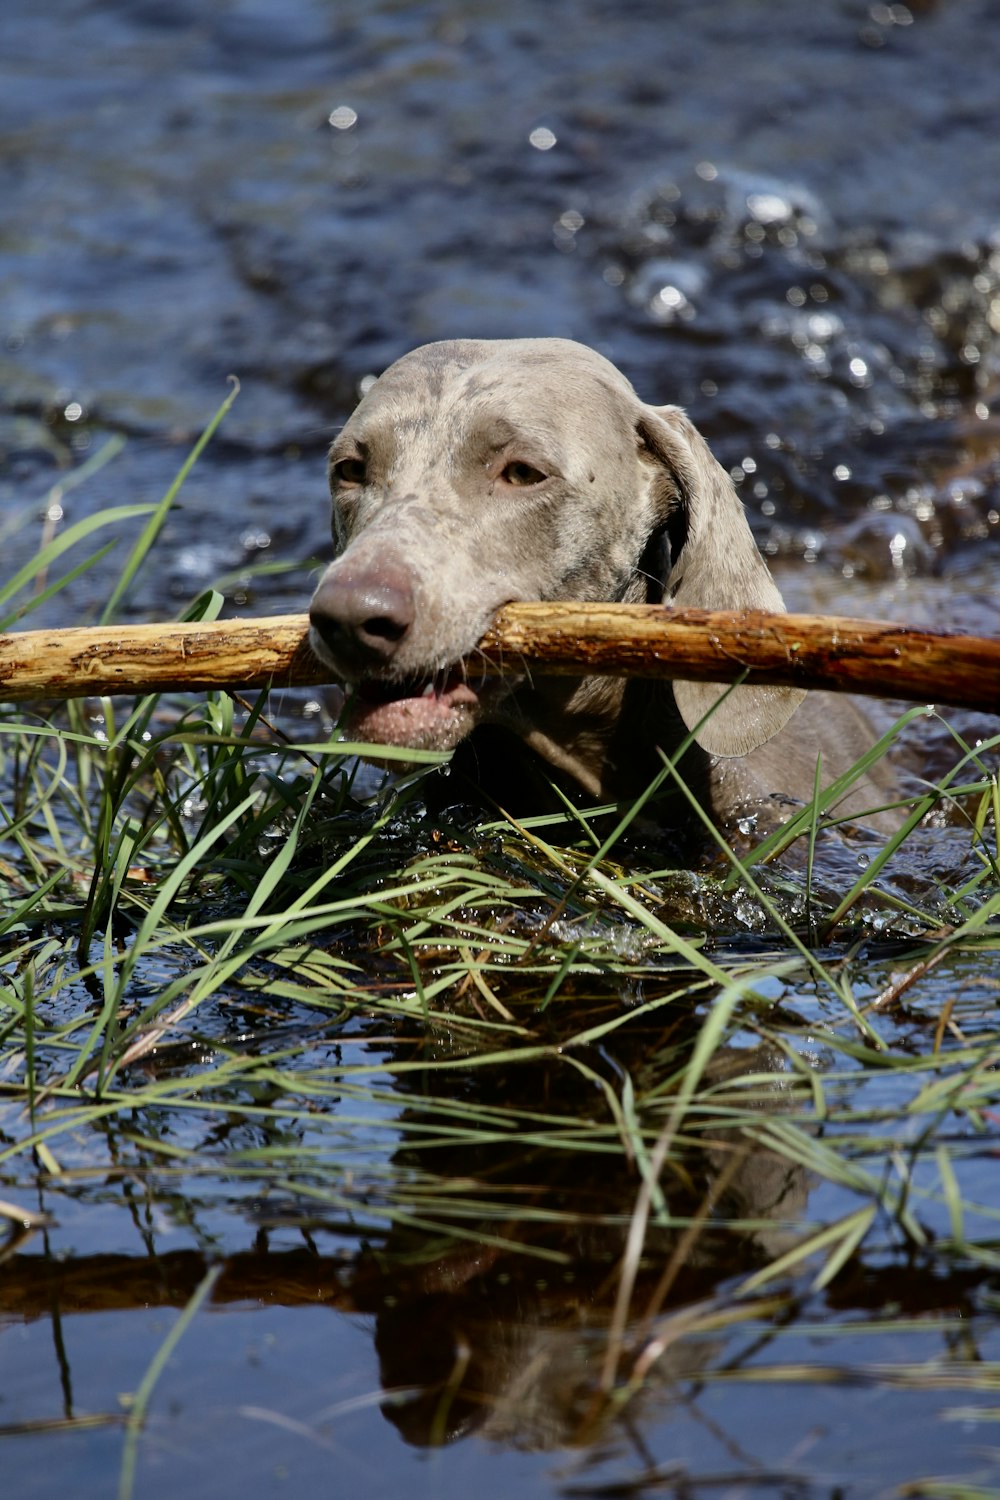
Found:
[342,668,499,750]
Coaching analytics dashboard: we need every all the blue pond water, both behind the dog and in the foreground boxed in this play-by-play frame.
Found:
[0,0,1000,1500]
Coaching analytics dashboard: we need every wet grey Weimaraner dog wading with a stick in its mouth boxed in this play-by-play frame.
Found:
[310,339,886,827]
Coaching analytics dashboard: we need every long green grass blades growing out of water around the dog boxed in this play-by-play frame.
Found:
[0,413,1000,1494]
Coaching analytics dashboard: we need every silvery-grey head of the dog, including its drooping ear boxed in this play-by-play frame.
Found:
[310,339,801,756]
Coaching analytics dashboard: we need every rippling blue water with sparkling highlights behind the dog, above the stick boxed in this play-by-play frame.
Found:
[0,0,1000,623]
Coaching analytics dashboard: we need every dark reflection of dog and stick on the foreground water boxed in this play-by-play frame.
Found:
[0,1080,991,1452]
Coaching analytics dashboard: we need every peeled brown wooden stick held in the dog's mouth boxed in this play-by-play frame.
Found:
[0,603,1000,713]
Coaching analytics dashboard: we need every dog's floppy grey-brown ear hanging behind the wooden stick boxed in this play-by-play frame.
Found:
[639,407,805,756]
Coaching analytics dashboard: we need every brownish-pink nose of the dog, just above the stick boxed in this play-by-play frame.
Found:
[309,564,415,677]
